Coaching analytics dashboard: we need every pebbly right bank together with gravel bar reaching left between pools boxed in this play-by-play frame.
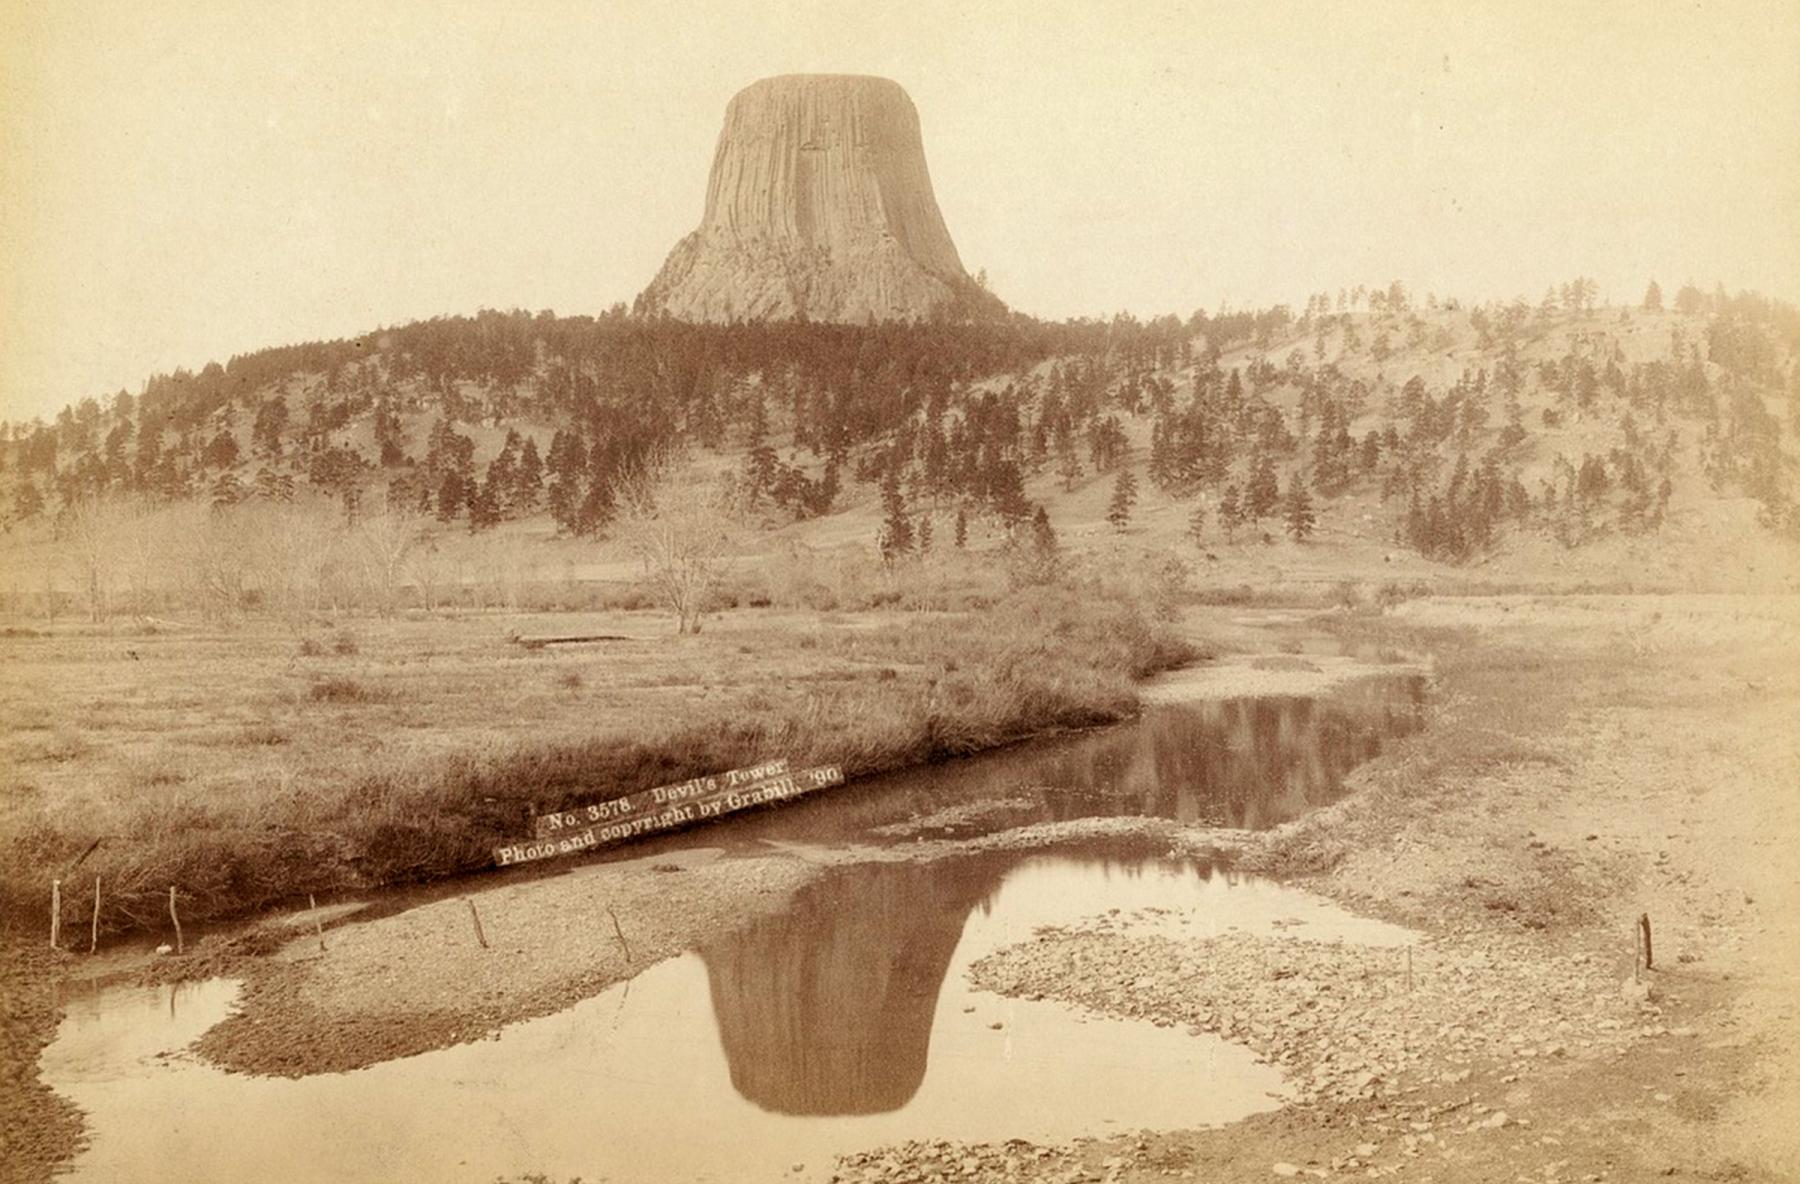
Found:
[17,597,1800,1180]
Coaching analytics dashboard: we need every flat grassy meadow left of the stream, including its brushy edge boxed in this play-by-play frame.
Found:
[0,554,1192,932]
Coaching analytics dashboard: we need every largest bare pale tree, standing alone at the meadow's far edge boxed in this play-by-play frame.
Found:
[612,455,743,633]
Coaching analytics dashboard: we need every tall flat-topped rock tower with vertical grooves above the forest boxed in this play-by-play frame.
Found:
[637,74,1001,324]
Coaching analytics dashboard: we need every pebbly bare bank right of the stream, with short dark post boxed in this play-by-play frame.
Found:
[835,597,1800,1182]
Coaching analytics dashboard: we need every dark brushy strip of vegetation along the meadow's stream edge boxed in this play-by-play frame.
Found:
[0,575,1195,946]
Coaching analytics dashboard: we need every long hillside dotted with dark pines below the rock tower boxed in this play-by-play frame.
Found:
[0,279,1800,600]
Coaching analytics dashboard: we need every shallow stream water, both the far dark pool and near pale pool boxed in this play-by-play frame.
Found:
[41,677,1422,1184]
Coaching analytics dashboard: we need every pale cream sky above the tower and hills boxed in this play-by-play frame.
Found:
[0,0,1800,419]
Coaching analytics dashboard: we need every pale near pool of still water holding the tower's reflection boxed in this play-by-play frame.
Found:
[43,855,1408,1182]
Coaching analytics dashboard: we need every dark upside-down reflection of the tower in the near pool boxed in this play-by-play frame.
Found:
[700,857,1015,1116]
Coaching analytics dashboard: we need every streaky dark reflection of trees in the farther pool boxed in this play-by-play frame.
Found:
[1031,678,1424,830]
